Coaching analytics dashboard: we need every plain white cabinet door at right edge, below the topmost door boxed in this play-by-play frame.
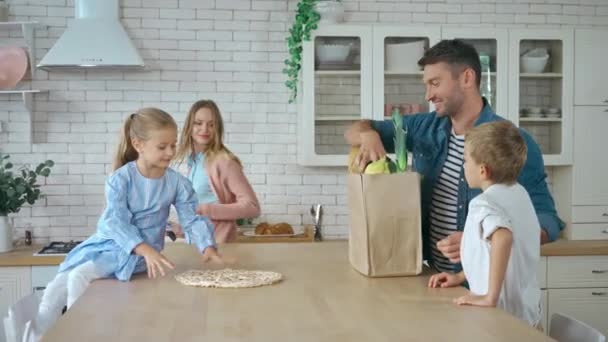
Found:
[572,105,608,204]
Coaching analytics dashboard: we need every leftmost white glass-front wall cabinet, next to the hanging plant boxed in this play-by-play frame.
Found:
[298,25,372,166]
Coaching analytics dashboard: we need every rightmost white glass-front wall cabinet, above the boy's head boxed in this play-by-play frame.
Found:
[509,29,574,165]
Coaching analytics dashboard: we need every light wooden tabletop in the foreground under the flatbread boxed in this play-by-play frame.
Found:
[43,242,550,342]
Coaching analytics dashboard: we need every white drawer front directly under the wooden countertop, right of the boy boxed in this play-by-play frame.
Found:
[547,255,608,289]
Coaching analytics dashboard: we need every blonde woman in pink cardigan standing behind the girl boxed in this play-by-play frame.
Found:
[172,100,260,243]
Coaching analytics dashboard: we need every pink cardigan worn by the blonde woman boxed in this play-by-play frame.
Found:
[197,155,260,243]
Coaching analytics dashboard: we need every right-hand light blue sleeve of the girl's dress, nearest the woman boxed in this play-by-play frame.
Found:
[174,175,215,253]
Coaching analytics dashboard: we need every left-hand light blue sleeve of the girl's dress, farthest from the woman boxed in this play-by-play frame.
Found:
[99,174,144,254]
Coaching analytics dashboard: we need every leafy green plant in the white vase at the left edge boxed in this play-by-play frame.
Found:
[0,153,55,216]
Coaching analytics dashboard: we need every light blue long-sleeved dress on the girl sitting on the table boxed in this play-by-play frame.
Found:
[59,162,215,281]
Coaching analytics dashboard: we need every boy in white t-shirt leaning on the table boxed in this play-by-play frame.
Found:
[429,121,541,327]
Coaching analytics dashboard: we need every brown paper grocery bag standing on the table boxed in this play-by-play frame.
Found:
[347,172,422,277]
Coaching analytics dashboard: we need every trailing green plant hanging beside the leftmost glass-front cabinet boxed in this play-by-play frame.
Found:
[283,0,321,103]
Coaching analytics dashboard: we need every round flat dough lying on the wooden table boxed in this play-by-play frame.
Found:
[175,268,283,288]
